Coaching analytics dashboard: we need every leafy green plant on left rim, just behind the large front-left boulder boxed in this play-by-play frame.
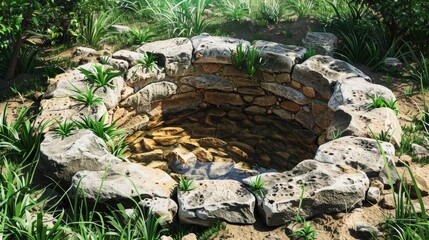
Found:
[76,114,124,142]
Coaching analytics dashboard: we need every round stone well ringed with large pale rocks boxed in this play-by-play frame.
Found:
[38,35,401,226]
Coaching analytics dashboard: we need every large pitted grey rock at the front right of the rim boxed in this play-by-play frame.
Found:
[243,160,369,226]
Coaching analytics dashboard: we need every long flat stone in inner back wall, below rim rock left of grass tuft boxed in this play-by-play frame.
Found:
[180,74,233,92]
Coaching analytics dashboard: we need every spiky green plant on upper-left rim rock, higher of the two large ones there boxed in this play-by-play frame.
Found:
[78,65,123,88]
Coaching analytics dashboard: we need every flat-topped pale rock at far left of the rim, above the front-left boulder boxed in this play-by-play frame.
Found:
[35,97,108,129]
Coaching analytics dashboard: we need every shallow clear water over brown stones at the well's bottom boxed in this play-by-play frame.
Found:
[123,107,318,175]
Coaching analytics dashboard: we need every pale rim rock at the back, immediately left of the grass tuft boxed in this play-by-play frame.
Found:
[191,34,250,64]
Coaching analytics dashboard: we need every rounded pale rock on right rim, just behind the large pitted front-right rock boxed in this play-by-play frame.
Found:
[314,136,395,184]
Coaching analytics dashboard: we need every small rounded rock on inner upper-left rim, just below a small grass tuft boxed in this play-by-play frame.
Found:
[125,65,165,91]
